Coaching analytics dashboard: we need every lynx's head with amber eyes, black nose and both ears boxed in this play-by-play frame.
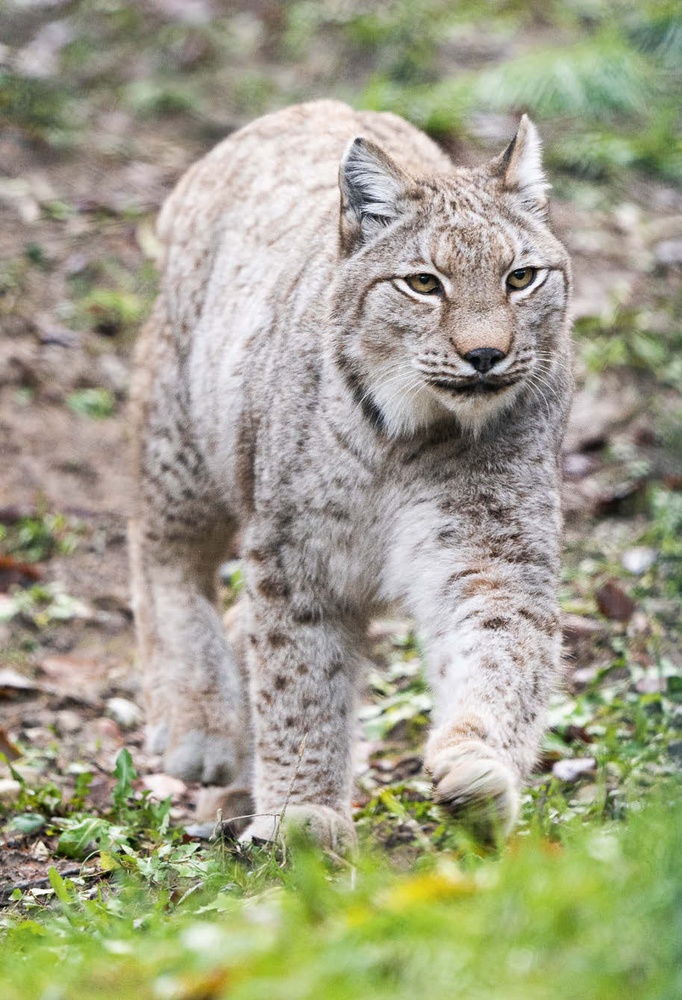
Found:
[333,115,571,436]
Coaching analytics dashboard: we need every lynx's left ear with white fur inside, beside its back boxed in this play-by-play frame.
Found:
[339,137,409,249]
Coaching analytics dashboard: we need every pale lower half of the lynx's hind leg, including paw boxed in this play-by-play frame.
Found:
[131,512,250,785]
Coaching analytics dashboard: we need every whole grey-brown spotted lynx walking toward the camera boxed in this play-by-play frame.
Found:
[130,101,572,847]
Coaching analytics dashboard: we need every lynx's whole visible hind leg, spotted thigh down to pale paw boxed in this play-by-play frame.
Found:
[129,330,251,785]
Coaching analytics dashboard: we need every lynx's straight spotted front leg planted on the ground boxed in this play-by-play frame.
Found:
[238,552,359,850]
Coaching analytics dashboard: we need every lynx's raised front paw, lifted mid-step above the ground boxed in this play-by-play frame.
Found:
[427,740,519,841]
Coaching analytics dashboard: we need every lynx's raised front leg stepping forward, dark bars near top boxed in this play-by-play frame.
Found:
[396,484,561,836]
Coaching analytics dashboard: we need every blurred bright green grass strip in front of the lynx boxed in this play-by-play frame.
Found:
[0,793,682,1000]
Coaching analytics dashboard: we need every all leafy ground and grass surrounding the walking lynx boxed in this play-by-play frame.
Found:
[0,0,682,1000]
